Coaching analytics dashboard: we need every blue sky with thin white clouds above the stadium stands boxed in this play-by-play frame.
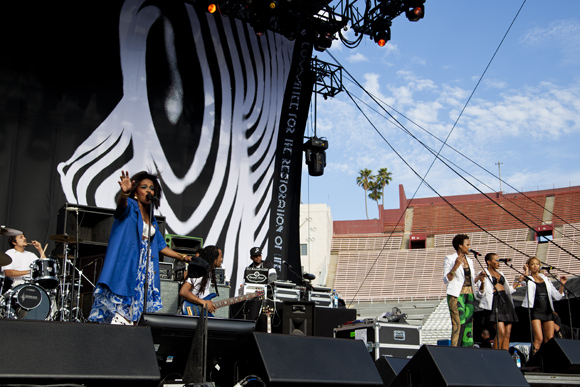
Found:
[302,0,580,220]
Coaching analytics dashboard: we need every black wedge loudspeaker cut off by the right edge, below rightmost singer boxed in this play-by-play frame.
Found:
[526,337,580,374]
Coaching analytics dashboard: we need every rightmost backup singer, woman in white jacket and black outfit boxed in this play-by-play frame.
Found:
[520,257,568,354]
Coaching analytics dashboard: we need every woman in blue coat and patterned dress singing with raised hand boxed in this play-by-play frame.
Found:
[88,171,191,325]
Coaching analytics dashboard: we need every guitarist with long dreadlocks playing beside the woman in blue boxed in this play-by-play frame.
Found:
[179,246,224,313]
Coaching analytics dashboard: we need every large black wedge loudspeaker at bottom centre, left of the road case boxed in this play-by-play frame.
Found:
[240,333,383,387]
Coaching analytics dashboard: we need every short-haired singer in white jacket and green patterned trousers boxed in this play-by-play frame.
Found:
[443,234,485,347]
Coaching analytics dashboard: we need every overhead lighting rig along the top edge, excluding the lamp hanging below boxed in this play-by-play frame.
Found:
[195,0,425,52]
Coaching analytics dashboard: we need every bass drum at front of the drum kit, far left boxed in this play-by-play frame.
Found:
[10,284,51,320]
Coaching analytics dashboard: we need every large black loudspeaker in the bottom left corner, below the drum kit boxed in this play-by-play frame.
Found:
[0,320,160,386]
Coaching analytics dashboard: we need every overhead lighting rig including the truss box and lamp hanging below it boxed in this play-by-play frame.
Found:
[186,0,425,176]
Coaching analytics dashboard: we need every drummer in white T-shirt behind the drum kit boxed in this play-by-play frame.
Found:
[4,234,46,287]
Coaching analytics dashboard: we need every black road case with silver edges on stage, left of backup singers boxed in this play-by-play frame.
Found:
[334,319,421,360]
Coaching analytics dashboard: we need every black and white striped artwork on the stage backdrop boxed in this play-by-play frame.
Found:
[57,0,310,292]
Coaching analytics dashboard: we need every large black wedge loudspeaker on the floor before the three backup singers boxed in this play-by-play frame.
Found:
[390,345,529,387]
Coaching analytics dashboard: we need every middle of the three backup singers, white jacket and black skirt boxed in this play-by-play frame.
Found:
[476,253,518,350]
